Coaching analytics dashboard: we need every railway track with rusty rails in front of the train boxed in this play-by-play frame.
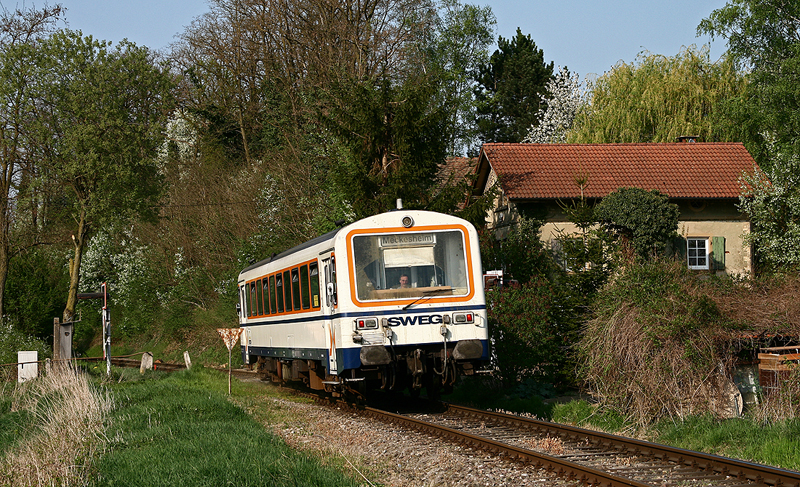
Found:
[356,405,800,487]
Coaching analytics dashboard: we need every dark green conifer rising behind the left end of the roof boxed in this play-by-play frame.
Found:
[475,28,553,146]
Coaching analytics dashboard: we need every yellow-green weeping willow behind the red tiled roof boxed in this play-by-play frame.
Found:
[568,47,745,144]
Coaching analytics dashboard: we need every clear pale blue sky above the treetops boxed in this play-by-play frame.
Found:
[51,0,726,78]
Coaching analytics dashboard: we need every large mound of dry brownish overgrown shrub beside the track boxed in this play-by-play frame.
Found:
[578,259,733,424]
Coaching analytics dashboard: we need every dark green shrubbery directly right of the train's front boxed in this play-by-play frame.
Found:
[481,219,593,387]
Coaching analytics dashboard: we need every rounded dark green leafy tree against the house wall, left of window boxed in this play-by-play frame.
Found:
[594,188,679,260]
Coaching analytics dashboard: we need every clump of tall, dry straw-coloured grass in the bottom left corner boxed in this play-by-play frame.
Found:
[0,367,112,487]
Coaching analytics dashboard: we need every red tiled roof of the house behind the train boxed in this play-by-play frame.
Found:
[479,142,756,200]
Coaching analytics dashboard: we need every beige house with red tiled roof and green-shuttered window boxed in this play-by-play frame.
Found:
[473,143,757,275]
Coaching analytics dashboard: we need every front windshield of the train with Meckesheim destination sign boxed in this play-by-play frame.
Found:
[353,230,469,301]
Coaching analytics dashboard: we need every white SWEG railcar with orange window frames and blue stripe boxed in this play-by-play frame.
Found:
[237,208,489,398]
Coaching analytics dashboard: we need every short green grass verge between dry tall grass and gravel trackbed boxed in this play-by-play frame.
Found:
[91,367,358,487]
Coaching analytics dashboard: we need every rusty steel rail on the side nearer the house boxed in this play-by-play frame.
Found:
[446,404,800,487]
